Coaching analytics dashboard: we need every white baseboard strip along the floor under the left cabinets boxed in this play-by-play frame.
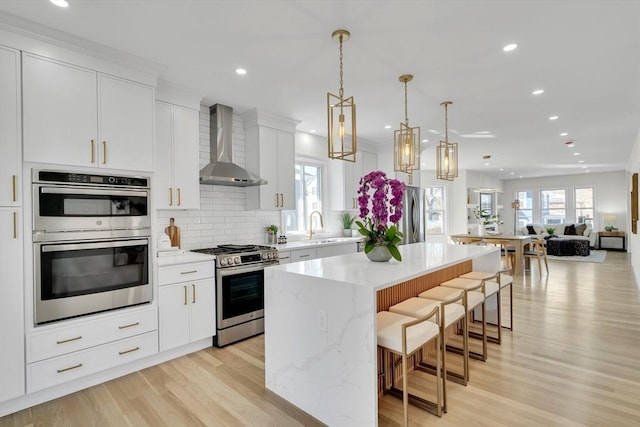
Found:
[0,338,213,417]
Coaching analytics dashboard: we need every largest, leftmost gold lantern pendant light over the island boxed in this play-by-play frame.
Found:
[327,30,357,162]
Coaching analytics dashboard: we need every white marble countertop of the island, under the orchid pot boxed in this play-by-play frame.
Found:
[269,243,498,290]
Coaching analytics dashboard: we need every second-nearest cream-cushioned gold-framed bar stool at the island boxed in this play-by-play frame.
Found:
[389,291,467,412]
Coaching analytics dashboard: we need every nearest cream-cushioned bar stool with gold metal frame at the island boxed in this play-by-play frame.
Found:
[376,306,442,427]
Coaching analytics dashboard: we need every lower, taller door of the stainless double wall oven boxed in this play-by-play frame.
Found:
[34,238,152,324]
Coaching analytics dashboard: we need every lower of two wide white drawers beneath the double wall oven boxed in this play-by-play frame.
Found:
[27,331,158,393]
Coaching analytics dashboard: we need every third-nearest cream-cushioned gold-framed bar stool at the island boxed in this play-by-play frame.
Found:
[418,286,469,386]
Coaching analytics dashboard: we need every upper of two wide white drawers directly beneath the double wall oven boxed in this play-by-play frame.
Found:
[27,307,158,363]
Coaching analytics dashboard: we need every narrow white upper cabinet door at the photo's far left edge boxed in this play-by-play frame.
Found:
[0,46,22,206]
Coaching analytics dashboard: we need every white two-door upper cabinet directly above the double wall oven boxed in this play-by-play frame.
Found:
[22,53,154,171]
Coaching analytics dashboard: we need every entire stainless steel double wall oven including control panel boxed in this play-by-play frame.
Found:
[32,169,152,324]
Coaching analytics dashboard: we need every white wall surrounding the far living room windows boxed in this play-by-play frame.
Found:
[503,171,629,237]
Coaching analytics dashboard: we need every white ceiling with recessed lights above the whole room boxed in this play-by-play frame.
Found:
[0,0,640,179]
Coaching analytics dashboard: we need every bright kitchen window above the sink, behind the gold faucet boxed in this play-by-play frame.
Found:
[283,159,324,233]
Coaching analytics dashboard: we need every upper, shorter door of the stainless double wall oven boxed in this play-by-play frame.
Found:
[33,184,151,240]
